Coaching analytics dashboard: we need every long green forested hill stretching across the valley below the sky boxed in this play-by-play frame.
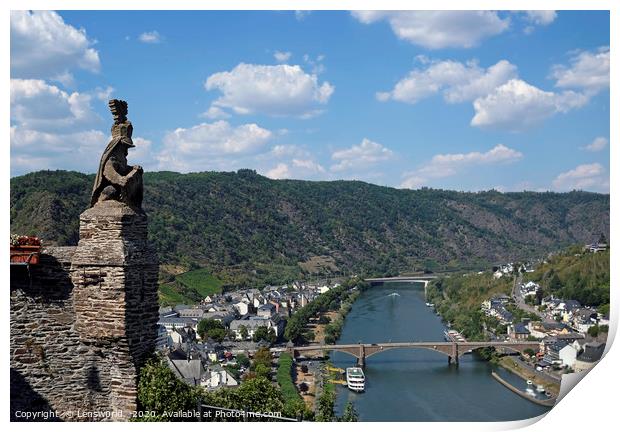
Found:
[11,170,609,273]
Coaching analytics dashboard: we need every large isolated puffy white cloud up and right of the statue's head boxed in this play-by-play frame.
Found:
[205,63,334,117]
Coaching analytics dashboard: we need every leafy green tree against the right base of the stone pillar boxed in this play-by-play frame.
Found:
[138,357,199,421]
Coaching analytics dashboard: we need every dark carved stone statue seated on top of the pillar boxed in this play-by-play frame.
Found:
[90,99,143,211]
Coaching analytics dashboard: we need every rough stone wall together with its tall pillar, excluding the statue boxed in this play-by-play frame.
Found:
[11,202,158,420]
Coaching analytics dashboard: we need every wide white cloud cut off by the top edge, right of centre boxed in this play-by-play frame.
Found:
[352,11,510,49]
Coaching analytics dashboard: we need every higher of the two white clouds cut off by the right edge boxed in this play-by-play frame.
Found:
[551,47,610,93]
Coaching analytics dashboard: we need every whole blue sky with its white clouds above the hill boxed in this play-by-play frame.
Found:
[11,11,610,193]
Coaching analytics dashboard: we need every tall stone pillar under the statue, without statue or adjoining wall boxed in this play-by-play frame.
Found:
[71,200,159,413]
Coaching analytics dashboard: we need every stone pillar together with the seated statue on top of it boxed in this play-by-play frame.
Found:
[71,99,159,412]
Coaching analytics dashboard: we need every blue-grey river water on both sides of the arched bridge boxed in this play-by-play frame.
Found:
[331,283,548,421]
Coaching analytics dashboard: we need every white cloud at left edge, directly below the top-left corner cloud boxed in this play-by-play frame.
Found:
[11,79,98,131]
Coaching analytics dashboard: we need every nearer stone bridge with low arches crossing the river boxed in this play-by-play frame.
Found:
[271,342,540,367]
